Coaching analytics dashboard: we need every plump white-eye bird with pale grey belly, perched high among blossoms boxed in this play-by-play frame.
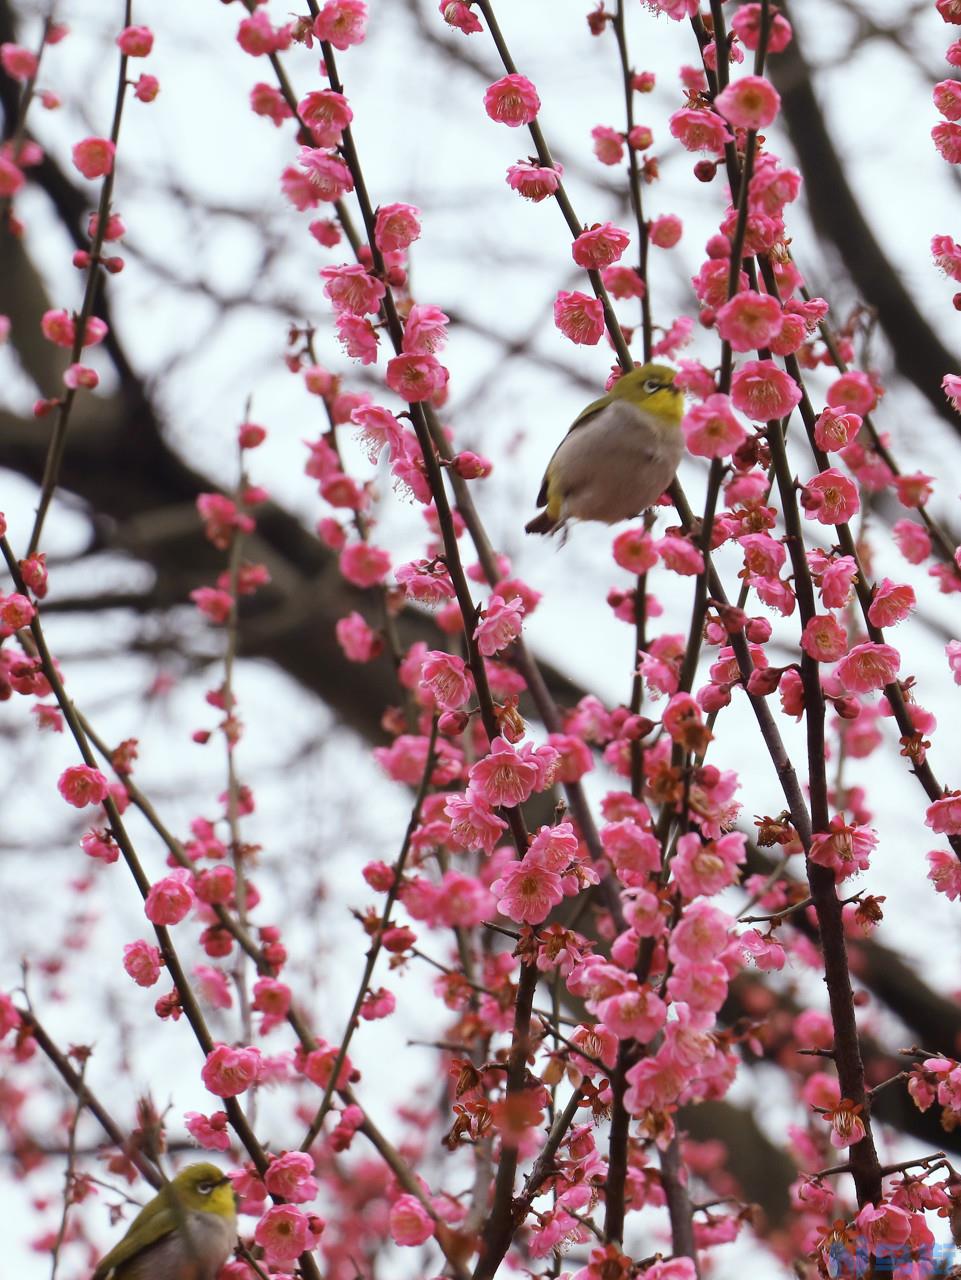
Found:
[526,364,685,534]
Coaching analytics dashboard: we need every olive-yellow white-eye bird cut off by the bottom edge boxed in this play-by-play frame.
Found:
[92,1162,237,1280]
